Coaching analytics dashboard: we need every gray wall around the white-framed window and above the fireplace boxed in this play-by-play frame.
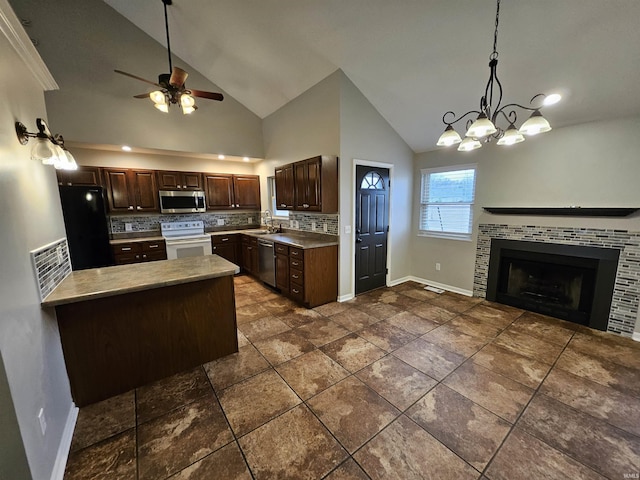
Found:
[412,117,640,291]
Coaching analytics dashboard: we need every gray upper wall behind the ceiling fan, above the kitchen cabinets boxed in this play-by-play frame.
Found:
[12,0,263,158]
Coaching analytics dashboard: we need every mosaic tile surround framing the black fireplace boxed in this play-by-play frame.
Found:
[473,224,640,336]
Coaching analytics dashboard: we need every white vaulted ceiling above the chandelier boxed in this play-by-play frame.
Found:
[81,0,640,152]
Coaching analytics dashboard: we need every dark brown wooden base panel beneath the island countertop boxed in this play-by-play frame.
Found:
[56,276,238,407]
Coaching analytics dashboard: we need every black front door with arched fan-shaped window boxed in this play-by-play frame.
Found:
[355,165,389,295]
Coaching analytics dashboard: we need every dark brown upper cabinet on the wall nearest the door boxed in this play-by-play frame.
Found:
[276,156,338,213]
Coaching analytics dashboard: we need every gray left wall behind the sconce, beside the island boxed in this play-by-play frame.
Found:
[0,17,72,479]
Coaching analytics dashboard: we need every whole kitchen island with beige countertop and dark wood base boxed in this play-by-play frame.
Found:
[42,255,239,407]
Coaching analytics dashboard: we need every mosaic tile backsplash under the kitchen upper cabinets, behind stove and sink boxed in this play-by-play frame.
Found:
[109,211,339,235]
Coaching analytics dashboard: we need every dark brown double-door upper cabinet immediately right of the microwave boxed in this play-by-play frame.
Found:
[204,173,260,210]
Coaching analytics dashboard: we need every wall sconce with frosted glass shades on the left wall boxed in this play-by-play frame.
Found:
[15,118,78,170]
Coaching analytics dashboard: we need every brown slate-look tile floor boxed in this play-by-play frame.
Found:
[65,276,640,480]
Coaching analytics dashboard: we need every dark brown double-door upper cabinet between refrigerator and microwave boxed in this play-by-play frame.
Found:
[103,168,160,212]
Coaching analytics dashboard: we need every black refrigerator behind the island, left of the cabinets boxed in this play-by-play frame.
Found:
[59,185,114,270]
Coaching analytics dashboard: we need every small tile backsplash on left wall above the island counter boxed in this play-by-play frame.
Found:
[31,238,71,300]
